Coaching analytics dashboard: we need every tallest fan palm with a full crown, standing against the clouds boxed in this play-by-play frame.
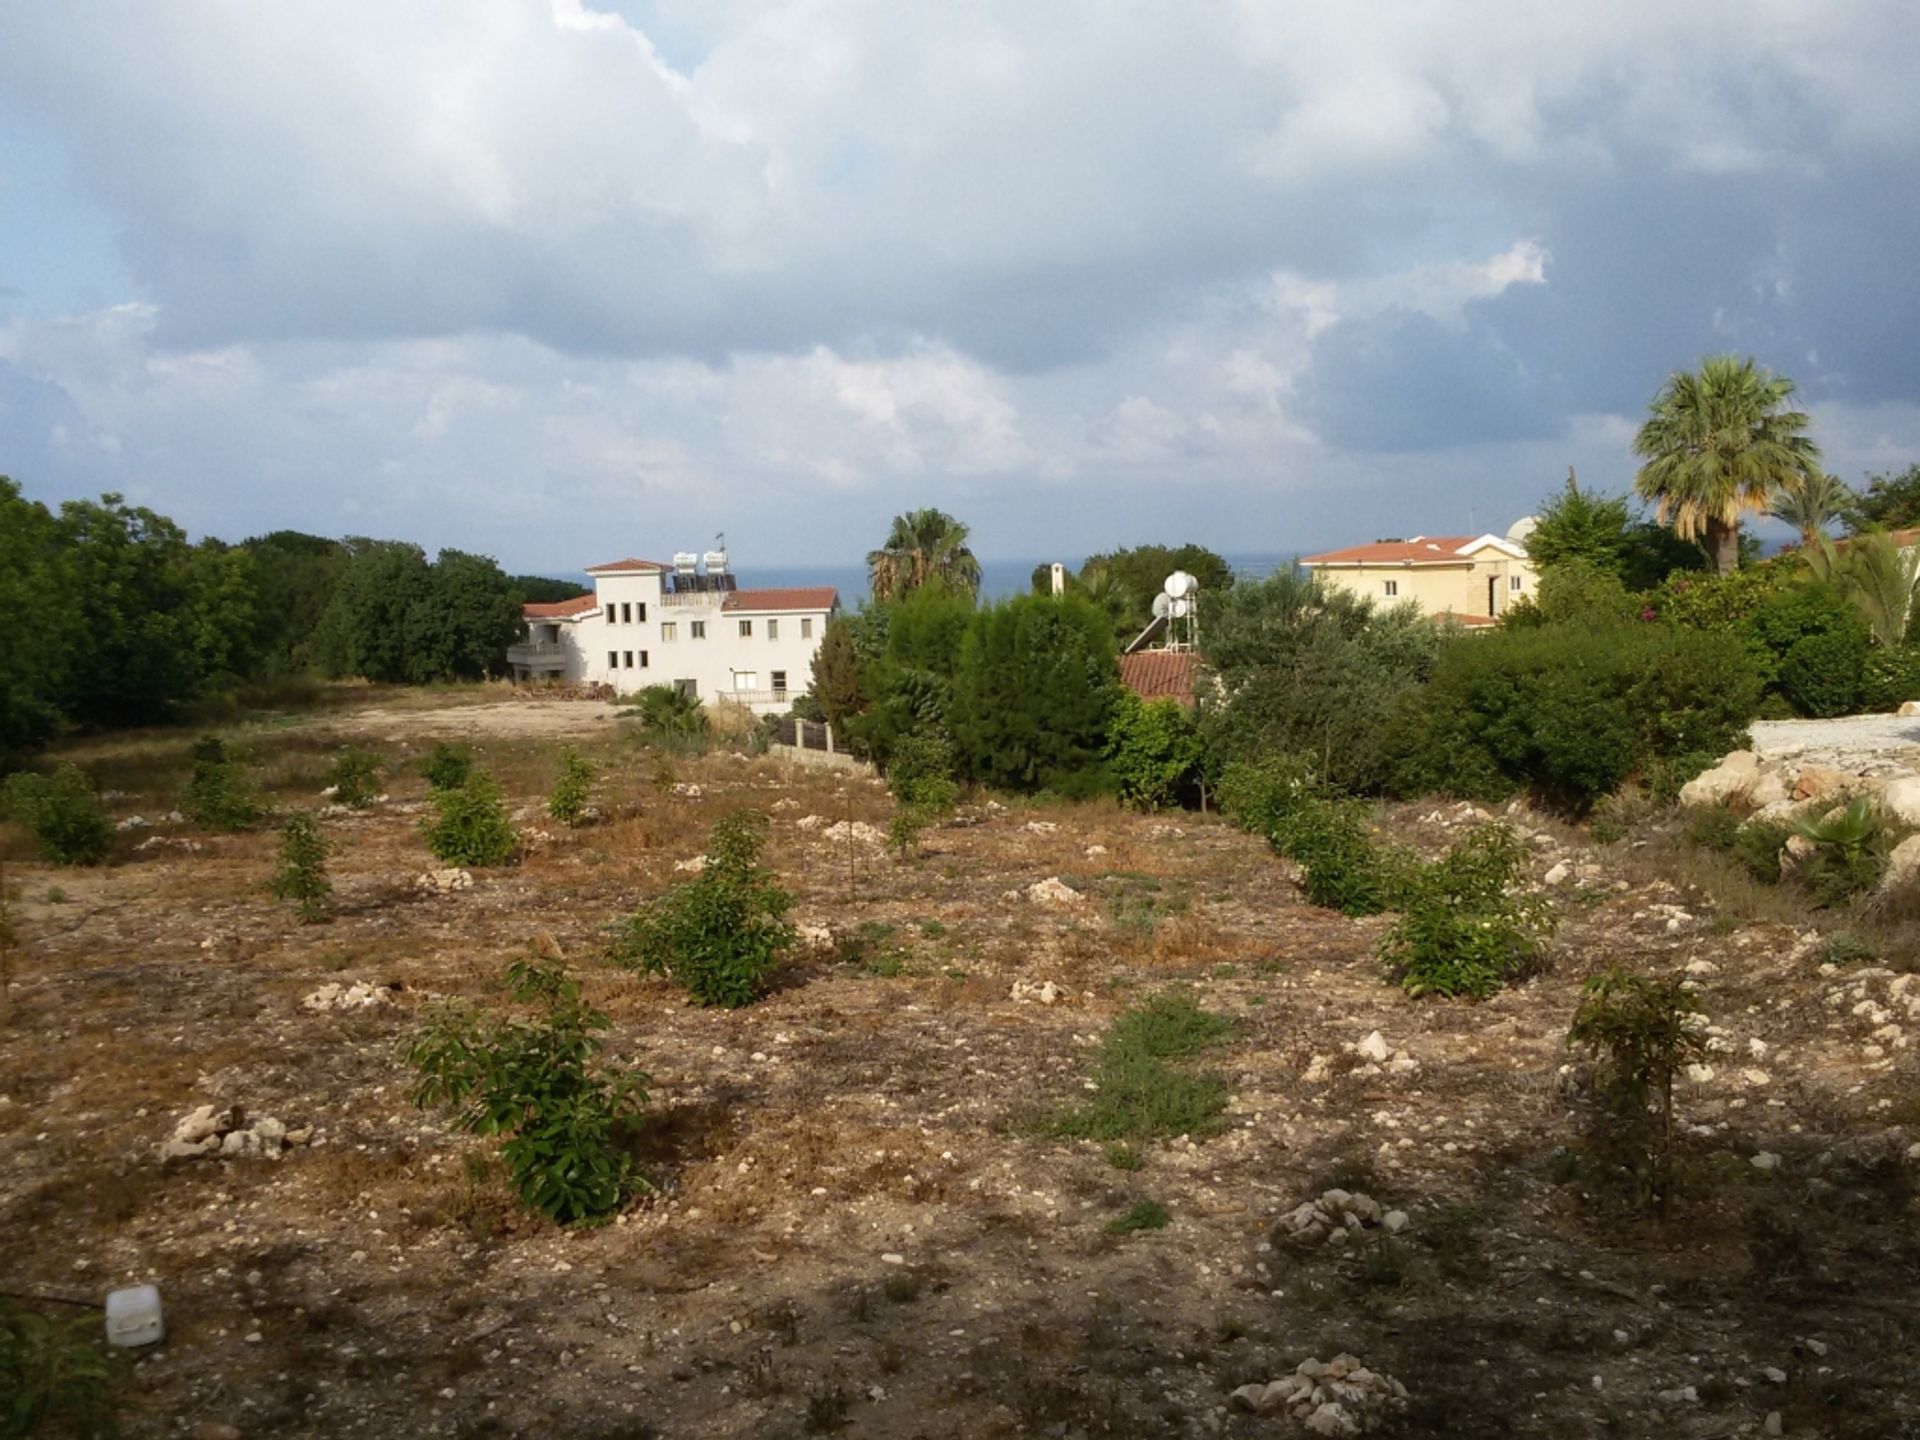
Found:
[1634,355,1820,574]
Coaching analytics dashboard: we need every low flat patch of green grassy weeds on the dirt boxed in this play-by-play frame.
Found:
[1035,991,1227,1142]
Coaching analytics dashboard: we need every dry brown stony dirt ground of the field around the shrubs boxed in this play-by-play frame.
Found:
[0,703,1920,1440]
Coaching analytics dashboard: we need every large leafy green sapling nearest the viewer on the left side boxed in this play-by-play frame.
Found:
[407,962,647,1225]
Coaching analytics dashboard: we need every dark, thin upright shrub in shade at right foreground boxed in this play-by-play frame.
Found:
[1567,970,1707,1213]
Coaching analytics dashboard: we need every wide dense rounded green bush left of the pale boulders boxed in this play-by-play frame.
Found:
[1396,624,1761,812]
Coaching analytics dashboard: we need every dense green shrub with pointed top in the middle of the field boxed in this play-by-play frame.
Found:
[611,810,795,1010]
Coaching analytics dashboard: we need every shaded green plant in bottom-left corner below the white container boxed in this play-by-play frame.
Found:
[0,1296,121,1440]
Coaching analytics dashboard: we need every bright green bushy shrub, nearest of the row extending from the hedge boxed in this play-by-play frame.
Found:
[1379,826,1555,1000]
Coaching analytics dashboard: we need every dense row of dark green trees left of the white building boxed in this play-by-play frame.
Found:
[0,476,580,762]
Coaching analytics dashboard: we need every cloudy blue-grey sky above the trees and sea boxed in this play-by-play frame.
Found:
[0,0,1920,570]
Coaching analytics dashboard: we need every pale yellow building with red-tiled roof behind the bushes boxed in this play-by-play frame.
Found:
[1300,516,1538,626]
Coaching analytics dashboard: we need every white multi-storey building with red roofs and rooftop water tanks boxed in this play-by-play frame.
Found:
[507,551,839,714]
